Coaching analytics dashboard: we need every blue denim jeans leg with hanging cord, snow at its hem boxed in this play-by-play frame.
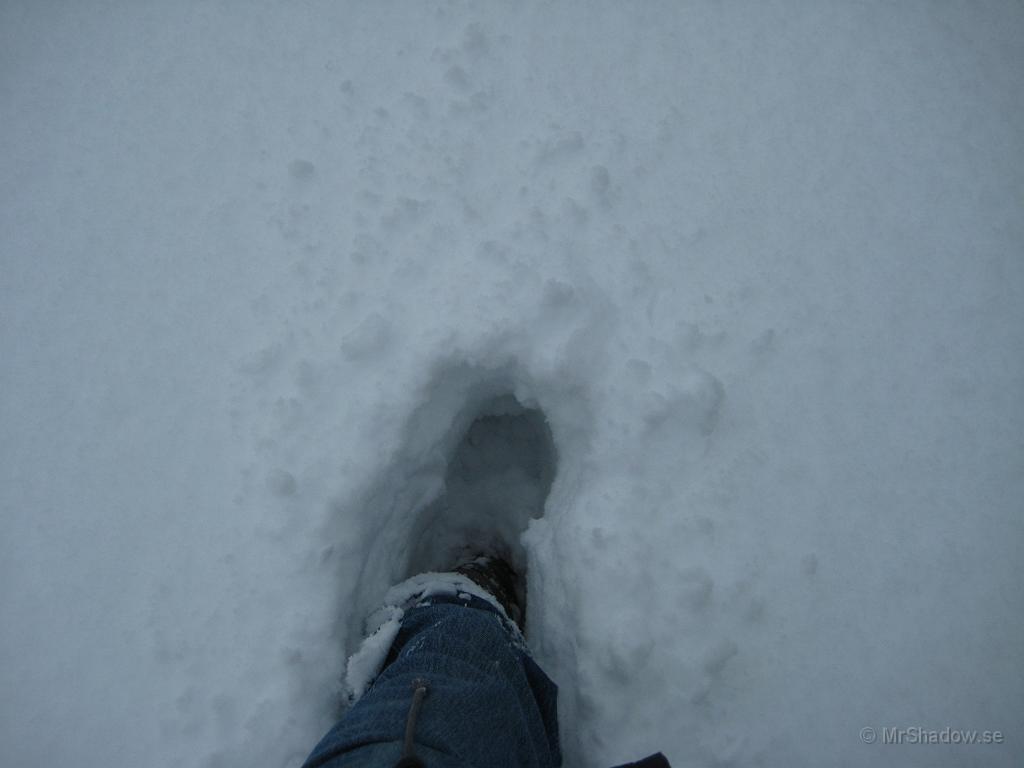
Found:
[304,595,562,768]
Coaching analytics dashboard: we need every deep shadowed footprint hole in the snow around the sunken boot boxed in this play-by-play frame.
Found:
[333,360,593,648]
